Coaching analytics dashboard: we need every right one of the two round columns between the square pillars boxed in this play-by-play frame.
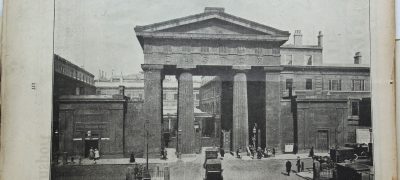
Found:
[232,66,250,152]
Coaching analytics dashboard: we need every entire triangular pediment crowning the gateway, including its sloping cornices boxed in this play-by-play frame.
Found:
[135,8,290,37]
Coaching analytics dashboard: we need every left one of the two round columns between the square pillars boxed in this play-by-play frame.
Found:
[178,69,195,154]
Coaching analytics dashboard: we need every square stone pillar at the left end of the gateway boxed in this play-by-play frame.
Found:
[142,64,164,157]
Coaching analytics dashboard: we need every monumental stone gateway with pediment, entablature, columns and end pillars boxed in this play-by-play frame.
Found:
[135,8,290,156]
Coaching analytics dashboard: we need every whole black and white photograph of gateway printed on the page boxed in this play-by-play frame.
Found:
[43,0,379,180]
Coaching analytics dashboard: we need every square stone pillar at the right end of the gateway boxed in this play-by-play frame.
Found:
[264,67,289,151]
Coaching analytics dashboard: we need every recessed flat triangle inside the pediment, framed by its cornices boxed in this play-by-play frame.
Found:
[159,18,270,35]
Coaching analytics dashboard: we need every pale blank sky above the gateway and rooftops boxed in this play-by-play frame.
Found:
[55,0,369,76]
